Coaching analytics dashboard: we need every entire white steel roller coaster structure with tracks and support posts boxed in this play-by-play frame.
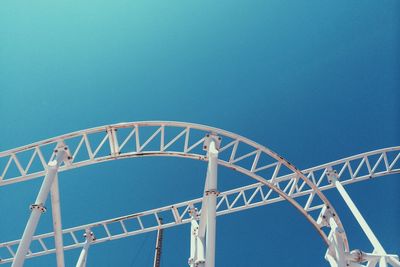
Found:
[0,121,400,267]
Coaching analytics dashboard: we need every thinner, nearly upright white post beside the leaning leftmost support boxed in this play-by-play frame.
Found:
[50,175,65,267]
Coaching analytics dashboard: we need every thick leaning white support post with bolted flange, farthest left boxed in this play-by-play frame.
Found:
[12,148,65,267]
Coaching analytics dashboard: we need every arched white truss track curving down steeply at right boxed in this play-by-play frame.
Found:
[0,121,347,245]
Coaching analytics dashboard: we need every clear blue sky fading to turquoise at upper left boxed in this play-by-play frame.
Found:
[0,0,400,267]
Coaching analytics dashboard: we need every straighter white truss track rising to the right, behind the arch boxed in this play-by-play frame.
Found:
[0,147,400,263]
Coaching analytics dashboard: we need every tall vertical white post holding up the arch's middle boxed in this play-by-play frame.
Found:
[205,140,218,267]
